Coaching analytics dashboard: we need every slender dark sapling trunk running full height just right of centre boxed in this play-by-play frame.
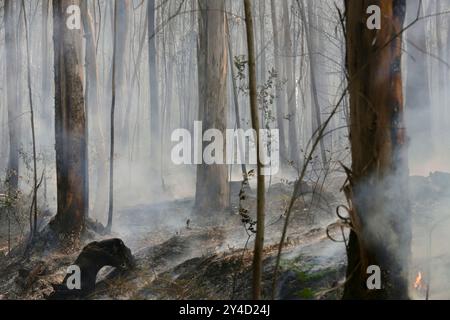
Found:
[244,0,266,300]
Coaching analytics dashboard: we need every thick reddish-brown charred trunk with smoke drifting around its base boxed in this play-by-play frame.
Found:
[344,0,411,299]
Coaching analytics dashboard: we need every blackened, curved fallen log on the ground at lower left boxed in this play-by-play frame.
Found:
[47,239,135,300]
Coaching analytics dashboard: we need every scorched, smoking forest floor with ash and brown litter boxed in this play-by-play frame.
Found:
[0,174,450,299]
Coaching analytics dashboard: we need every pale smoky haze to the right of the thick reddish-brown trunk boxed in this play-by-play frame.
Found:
[400,1,450,299]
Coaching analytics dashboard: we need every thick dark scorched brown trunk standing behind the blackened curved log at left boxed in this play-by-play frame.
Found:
[52,0,86,239]
